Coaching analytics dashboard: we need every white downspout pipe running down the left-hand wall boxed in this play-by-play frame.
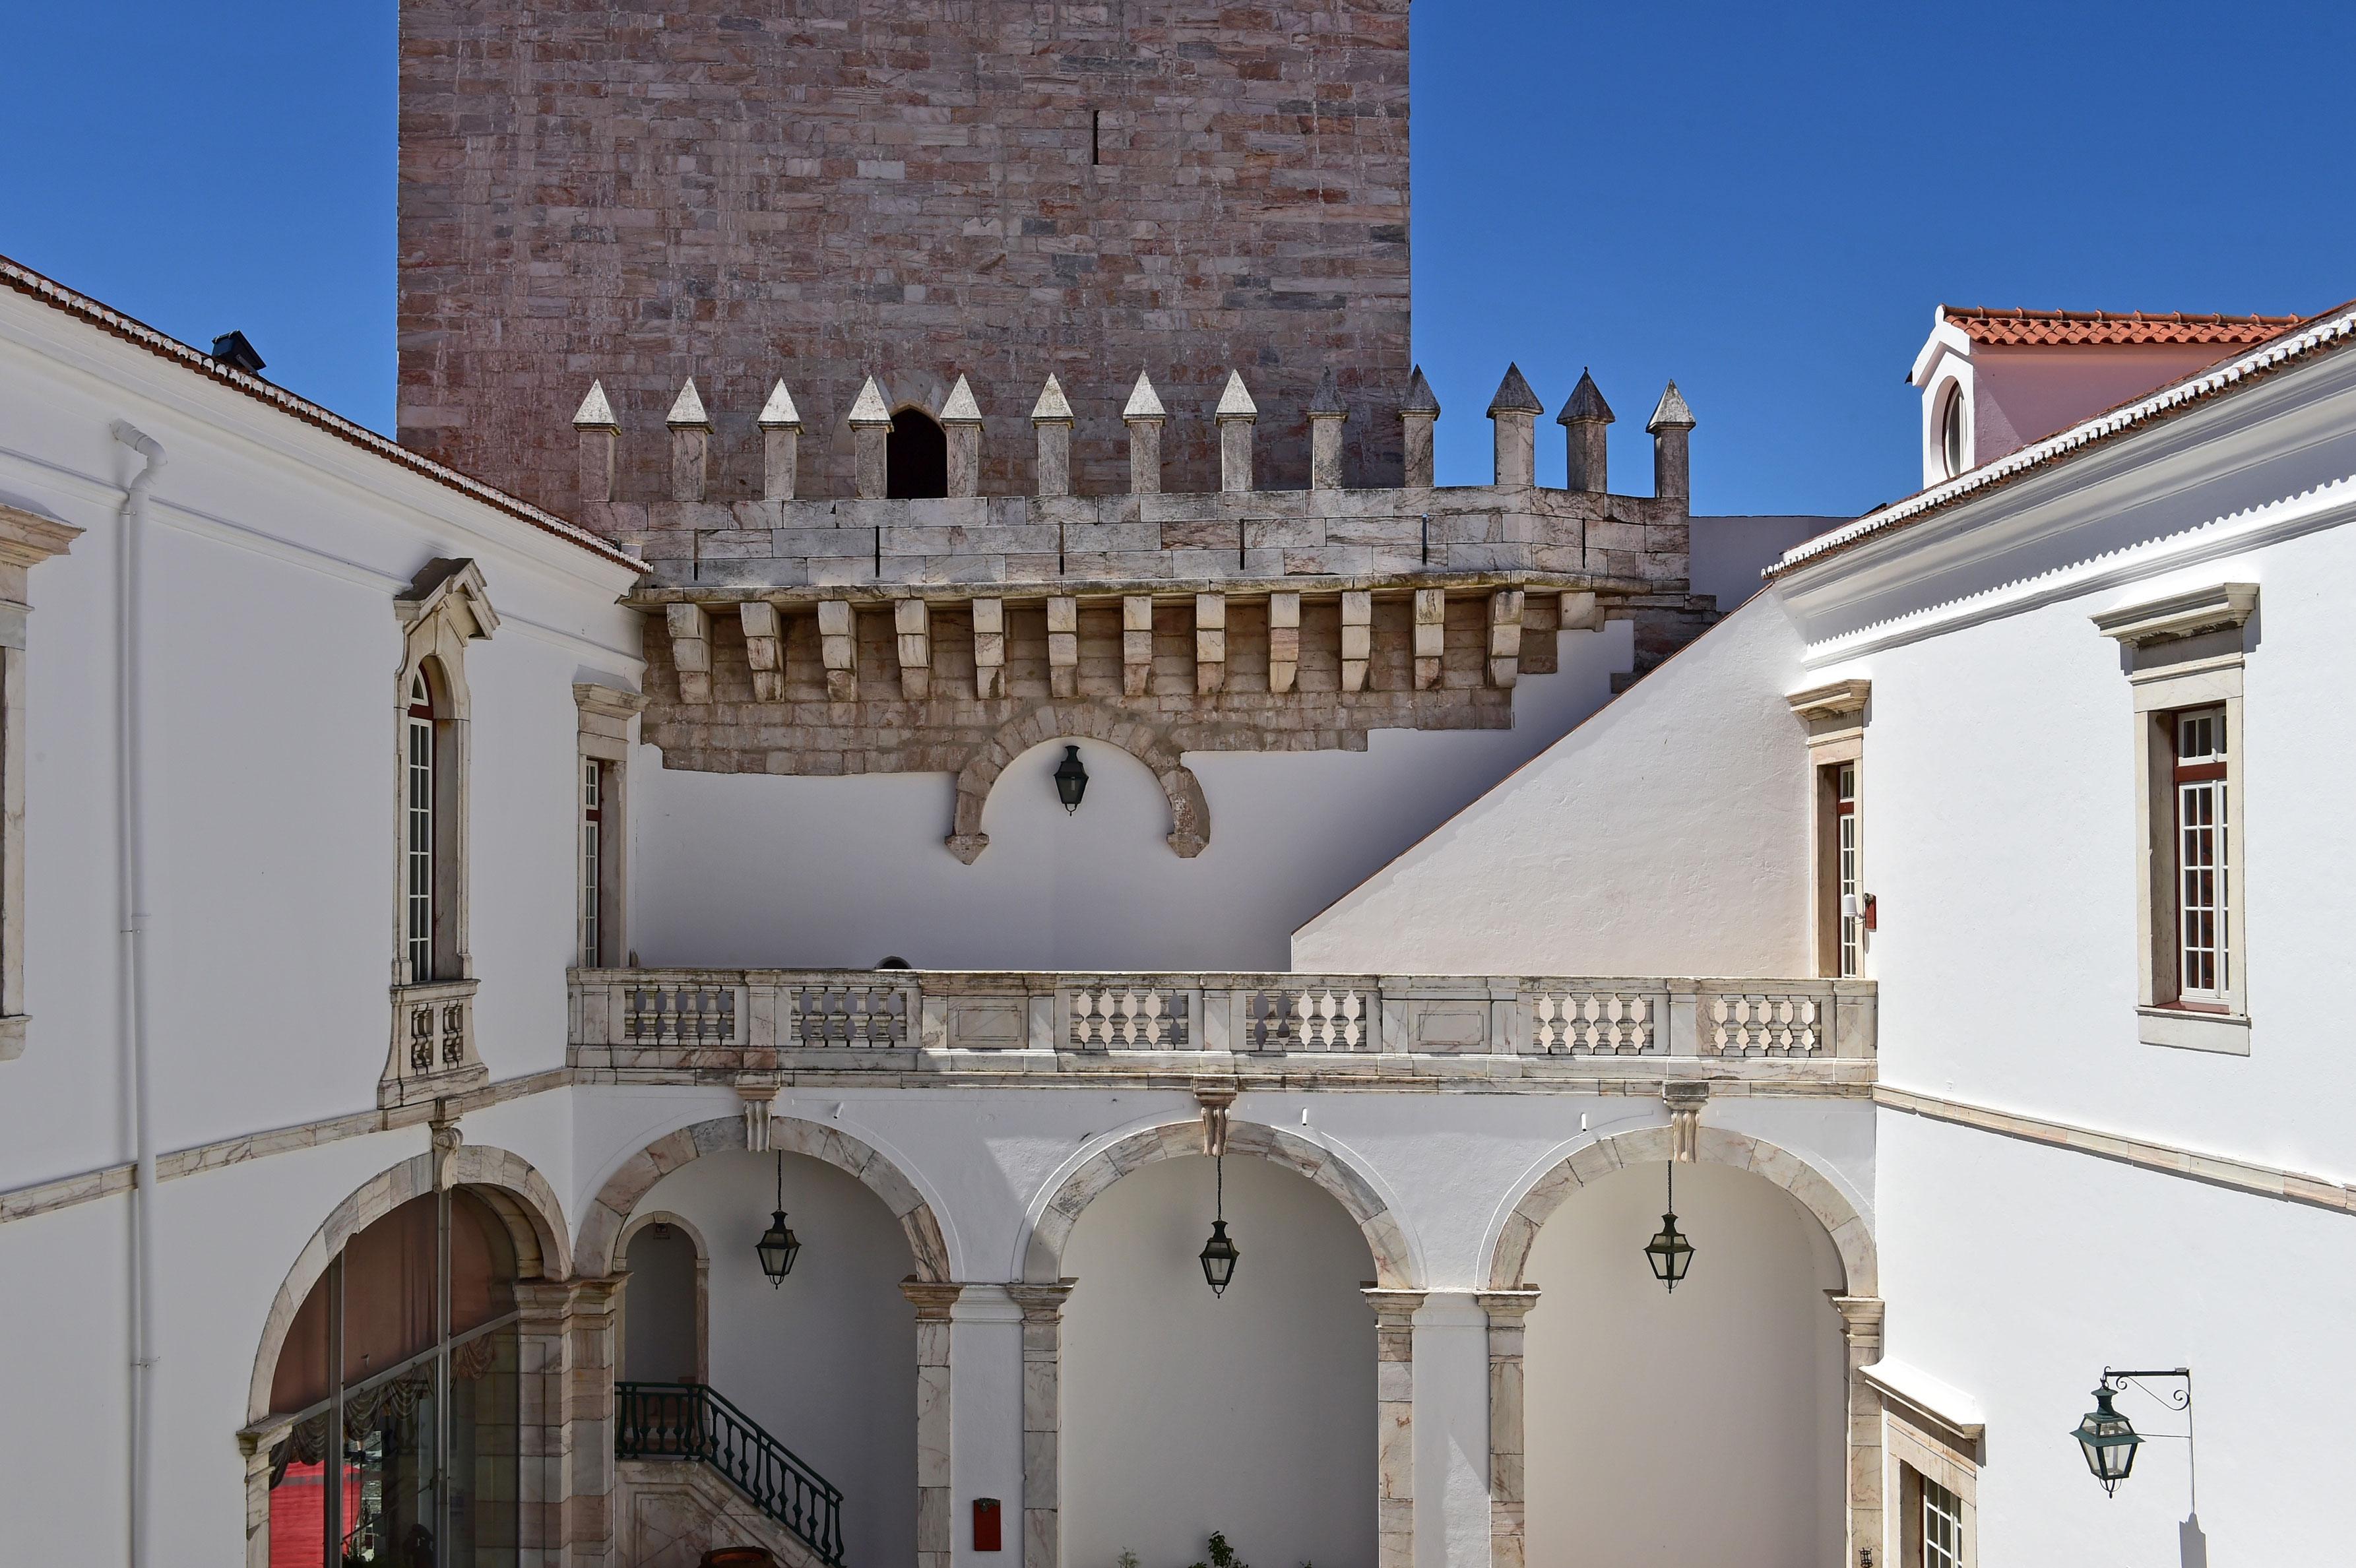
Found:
[113,419,165,1568]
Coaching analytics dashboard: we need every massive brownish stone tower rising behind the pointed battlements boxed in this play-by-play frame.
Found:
[398,0,1409,516]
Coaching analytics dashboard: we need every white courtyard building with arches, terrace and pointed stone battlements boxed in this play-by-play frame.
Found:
[0,33,2356,1568]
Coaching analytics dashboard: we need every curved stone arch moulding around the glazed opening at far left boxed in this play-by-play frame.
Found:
[245,1145,573,1422]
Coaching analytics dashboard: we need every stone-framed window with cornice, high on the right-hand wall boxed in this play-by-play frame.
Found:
[2092,584,2257,1055]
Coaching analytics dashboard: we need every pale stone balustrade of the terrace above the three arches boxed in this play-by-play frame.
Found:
[570,970,1876,1085]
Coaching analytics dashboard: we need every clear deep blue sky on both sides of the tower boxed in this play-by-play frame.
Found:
[0,0,2356,513]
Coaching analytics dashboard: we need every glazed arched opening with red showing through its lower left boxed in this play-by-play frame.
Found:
[271,1189,521,1568]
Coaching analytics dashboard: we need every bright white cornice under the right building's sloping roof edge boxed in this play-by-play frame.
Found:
[1800,476,2356,669]
